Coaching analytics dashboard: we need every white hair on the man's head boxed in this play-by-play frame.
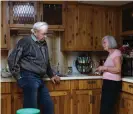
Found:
[31,22,48,33]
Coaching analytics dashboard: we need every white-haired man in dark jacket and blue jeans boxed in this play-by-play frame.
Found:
[8,22,60,114]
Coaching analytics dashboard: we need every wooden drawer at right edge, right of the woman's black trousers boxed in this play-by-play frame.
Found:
[122,82,133,94]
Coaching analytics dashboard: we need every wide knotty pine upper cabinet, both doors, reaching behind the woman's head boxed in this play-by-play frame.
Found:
[61,4,120,51]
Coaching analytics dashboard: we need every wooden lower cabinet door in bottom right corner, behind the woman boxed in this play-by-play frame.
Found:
[119,93,133,114]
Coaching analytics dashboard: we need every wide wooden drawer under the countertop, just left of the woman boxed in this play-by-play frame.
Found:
[71,80,102,89]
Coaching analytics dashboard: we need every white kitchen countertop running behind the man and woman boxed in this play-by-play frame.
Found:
[0,75,133,83]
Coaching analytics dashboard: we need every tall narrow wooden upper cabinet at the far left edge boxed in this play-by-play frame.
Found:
[0,1,10,50]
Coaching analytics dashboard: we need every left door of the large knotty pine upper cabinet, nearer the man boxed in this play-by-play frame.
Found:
[61,5,93,51]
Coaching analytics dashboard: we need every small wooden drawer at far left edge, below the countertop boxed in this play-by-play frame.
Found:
[1,82,11,93]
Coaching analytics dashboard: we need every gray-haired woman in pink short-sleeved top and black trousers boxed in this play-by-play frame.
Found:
[97,36,122,114]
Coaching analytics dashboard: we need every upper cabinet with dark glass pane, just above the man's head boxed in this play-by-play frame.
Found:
[39,1,65,31]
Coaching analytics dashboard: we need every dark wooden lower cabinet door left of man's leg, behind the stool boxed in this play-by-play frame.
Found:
[12,94,23,114]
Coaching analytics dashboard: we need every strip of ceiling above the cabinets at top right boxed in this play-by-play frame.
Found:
[79,0,133,6]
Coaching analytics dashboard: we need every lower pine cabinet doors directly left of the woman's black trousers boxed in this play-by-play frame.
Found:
[72,89,101,114]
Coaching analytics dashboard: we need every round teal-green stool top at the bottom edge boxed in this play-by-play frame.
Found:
[16,108,40,114]
